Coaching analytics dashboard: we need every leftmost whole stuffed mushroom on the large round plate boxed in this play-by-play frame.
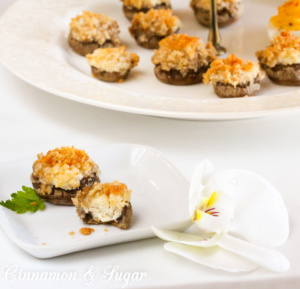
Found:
[68,11,120,55]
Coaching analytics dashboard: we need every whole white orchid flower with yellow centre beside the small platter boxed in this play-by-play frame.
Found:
[152,161,290,272]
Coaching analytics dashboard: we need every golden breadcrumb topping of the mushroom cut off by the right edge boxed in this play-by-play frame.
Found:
[256,31,300,67]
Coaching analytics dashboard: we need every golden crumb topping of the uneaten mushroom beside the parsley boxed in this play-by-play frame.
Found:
[33,147,100,193]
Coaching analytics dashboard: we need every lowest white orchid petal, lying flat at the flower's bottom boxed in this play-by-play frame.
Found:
[164,242,258,272]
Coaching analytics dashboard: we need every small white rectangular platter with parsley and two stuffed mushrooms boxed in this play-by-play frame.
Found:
[0,144,190,258]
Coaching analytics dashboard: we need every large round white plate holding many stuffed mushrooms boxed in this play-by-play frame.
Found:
[0,0,300,120]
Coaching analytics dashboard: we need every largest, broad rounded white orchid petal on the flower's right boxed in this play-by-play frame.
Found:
[208,170,289,247]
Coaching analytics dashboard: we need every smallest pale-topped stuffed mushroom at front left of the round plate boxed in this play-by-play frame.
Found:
[86,46,139,81]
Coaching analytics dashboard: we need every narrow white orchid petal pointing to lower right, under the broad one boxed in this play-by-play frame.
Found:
[218,234,290,272]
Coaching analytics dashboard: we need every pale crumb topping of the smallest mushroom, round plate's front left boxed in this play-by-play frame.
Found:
[86,46,139,73]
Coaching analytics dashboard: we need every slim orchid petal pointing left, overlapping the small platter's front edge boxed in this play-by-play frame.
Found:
[151,227,221,247]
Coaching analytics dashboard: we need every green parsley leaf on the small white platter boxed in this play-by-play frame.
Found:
[0,186,45,214]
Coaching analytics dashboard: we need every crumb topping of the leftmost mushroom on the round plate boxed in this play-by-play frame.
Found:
[70,11,120,46]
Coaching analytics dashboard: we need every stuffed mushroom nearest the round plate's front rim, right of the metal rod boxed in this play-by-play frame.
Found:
[203,54,264,98]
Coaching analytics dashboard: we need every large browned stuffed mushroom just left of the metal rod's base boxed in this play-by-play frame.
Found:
[152,34,216,85]
